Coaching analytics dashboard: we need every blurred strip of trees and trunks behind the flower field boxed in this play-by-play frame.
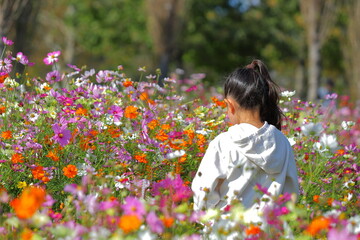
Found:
[0,0,360,102]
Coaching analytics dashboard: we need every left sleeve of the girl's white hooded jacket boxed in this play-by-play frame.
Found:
[191,139,226,210]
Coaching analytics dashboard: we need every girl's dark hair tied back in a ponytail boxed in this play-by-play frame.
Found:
[224,60,283,130]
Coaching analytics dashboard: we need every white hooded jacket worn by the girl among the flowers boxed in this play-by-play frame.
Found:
[191,122,299,210]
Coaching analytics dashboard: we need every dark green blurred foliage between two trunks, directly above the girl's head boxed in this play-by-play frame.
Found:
[184,0,304,88]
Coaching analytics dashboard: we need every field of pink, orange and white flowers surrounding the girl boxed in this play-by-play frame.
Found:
[0,37,360,240]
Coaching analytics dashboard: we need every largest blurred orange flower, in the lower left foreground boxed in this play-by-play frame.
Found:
[10,186,46,219]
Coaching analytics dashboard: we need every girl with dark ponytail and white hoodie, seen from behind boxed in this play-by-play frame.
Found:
[191,60,299,214]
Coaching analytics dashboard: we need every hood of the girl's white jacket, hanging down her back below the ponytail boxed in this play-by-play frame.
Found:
[228,122,291,174]
